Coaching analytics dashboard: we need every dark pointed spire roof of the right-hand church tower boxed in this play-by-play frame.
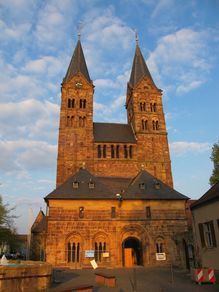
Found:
[129,44,155,87]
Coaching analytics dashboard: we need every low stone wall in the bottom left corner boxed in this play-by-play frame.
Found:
[0,261,52,292]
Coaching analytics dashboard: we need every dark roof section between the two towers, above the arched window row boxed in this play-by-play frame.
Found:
[93,123,136,143]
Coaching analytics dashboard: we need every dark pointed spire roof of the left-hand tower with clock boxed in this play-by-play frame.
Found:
[63,40,92,83]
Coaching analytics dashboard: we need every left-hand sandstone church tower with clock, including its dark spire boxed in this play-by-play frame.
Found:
[56,37,94,186]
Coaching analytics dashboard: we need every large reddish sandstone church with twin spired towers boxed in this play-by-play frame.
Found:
[32,37,188,269]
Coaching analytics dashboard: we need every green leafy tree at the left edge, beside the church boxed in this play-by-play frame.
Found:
[0,195,17,253]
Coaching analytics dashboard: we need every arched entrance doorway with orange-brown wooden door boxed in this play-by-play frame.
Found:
[122,237,143,267]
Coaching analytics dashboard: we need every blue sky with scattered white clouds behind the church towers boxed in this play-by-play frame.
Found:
[0,0,219,233]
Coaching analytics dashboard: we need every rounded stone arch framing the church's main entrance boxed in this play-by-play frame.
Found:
[120,224,151,266]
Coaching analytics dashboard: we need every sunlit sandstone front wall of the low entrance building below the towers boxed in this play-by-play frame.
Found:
[47,200,187,268]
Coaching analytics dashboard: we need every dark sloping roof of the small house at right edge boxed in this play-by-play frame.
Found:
[190,182,219,209]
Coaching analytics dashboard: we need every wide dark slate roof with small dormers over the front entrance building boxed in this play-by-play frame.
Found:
[44,169,188,201]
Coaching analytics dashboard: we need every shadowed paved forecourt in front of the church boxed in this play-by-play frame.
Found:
[49,267,219,292]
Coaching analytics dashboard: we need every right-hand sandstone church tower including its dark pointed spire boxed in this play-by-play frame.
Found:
[126,40,173,187]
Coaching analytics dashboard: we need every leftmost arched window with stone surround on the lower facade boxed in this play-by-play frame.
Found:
[65,232,84,266]
